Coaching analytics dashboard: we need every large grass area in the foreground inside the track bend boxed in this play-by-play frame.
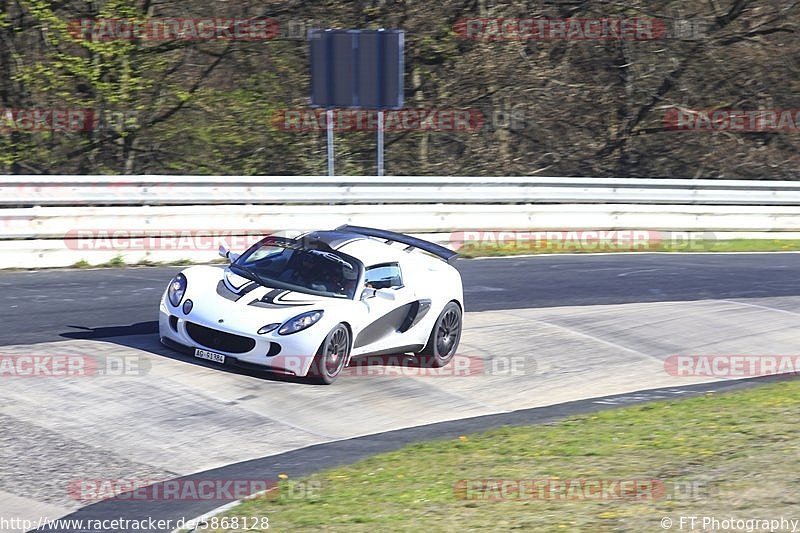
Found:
[205,380,800,532]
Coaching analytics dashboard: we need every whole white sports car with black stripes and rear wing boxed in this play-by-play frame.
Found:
[158,226,464,384]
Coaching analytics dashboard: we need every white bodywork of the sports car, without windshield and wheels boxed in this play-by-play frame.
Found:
[159,226,463,382]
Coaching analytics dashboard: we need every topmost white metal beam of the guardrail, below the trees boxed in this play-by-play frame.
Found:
[0,176,800,206]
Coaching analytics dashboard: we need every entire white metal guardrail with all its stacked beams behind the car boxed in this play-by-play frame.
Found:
[0,176,800,268]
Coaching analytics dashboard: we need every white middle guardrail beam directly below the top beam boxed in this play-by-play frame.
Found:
[0,204,800,240]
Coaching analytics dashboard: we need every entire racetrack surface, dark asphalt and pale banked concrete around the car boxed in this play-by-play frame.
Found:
[0,253,800,528]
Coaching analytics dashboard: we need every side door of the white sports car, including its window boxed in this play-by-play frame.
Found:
[353,263,419,355]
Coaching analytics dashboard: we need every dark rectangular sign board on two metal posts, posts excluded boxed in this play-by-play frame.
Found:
[308,30,405,110]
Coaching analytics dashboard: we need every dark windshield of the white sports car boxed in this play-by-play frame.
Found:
[231,237,363,299]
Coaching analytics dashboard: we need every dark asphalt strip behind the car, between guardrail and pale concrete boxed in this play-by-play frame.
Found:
[0,253,800,346]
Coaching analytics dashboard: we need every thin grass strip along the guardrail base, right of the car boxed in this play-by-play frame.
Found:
[458,239,800,258]
